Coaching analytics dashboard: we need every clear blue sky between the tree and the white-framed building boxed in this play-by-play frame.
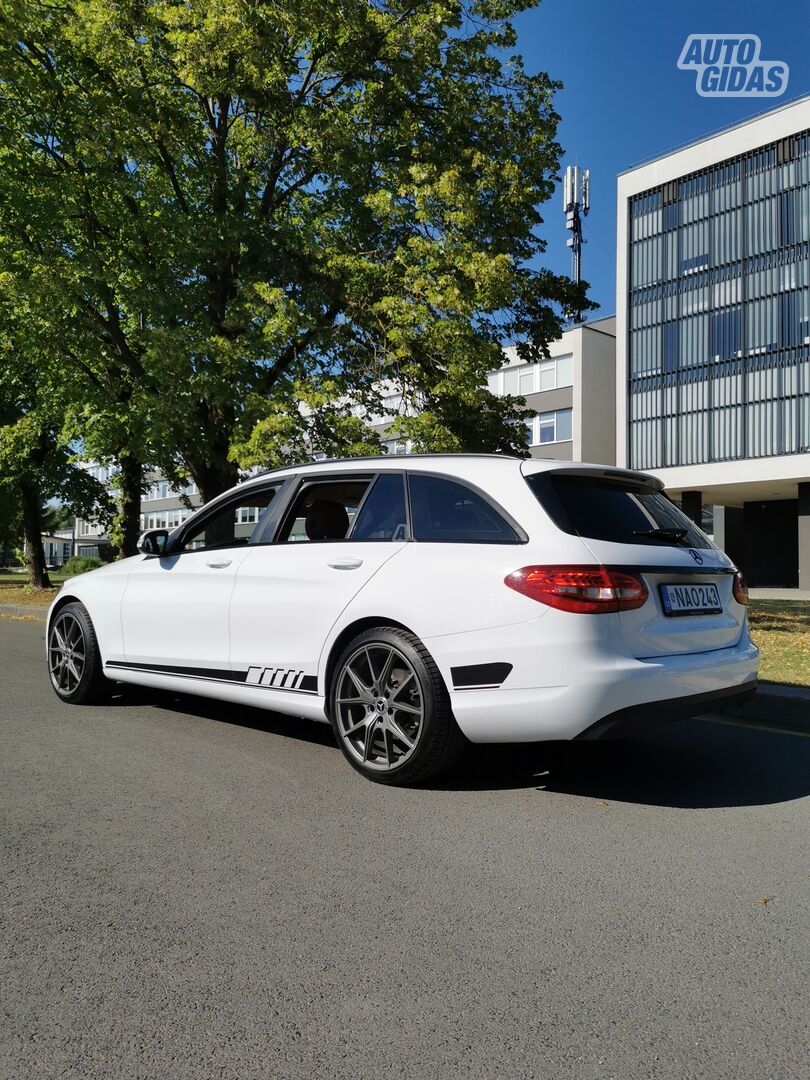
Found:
[515,0,810,318]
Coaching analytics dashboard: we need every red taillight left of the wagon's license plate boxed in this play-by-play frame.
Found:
[503,566,649,615]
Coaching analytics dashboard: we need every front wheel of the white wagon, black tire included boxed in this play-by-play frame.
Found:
[48,600,111,705]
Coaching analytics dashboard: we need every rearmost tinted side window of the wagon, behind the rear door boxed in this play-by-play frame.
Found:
[408,473,519,543]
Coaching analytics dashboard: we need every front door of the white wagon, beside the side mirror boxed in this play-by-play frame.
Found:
[121,483,280,675]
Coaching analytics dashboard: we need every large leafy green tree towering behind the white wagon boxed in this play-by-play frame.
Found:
[0,0,588,518]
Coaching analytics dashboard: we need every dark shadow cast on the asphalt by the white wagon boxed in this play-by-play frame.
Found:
[111,686,810,809]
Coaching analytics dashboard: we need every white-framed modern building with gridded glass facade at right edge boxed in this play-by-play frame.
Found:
[616,97,810,589]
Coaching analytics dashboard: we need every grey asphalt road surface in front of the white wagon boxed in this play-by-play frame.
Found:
[0,620,810,1080]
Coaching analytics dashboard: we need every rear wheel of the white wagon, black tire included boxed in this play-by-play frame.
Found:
[329,626,468,784]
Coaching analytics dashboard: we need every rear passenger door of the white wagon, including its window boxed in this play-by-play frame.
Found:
[230,472,407,693]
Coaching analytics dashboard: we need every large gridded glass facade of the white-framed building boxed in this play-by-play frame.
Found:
[626,131,810,469]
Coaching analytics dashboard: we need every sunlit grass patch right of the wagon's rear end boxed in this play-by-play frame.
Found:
[750,600,810,686]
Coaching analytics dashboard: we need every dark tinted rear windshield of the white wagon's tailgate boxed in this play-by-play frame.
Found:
[526,473,711,548]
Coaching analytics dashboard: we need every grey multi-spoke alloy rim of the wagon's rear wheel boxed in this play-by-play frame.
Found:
[335,643,424,772]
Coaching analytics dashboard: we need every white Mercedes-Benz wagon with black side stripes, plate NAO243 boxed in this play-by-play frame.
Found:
[46,455,758,783]
